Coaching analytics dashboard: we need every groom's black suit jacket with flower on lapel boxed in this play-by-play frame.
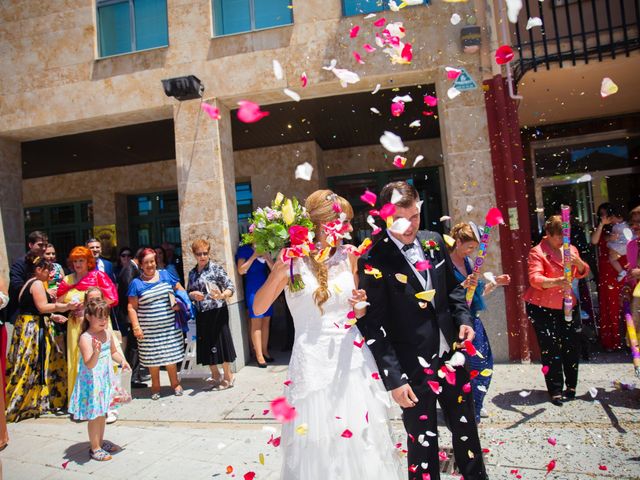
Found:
[358,231,472,390]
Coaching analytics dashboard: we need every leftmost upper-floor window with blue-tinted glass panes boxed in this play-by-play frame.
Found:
[97,0,169,57]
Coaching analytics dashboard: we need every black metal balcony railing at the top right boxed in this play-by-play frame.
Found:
[514,0,640,81]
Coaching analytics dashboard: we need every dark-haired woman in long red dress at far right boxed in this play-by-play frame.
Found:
[591,203,627,351]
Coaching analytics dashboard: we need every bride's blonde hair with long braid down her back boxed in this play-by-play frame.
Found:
[304,190,353,312]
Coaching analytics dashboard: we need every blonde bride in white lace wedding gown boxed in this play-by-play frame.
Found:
[253,190,405,480]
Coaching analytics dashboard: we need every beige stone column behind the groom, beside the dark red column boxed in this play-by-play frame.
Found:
[436,64,509,361]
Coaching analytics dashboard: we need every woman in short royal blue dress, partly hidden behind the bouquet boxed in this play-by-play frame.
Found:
[236,245,273,368]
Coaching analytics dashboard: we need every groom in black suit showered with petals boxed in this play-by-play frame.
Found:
[358,182,488,480]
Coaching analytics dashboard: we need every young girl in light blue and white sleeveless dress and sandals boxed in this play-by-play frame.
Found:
[69,300,130,461]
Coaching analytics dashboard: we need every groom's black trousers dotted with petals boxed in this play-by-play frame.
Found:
[402,354,488,480]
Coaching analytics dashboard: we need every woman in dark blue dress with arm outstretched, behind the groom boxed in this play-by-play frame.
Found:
[451,223,511,423]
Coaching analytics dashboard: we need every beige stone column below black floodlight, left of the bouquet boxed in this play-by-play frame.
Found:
[174,100,249,369]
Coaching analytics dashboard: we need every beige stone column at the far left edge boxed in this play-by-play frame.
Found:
[0,139,26,281]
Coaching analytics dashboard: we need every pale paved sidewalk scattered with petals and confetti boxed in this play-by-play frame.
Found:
[0,354,640,480]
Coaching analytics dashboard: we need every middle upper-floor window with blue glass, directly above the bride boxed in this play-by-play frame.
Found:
[212,0,293,36]
